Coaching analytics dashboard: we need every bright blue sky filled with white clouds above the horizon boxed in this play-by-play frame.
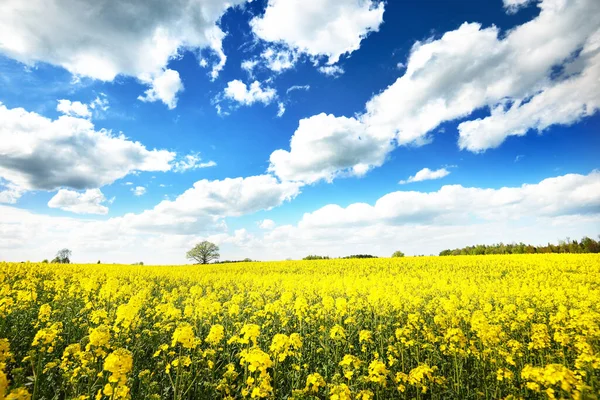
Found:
[0,0,600,264]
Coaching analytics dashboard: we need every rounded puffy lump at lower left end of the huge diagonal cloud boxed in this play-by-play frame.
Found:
[269,114,392,183]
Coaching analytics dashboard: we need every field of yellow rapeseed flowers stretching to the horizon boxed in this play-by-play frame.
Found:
[0,254,600,400]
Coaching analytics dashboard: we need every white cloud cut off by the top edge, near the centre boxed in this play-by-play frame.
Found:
[250,0,384,65]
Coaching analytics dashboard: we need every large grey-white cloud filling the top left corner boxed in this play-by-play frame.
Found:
[0,0,244,104]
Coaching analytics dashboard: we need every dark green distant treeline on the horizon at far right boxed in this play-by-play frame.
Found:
[440,237,600,256]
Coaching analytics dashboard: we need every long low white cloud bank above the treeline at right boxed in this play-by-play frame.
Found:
[299,171,600,227]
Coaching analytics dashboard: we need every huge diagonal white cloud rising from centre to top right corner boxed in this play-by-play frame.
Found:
[270,0,600,181]
